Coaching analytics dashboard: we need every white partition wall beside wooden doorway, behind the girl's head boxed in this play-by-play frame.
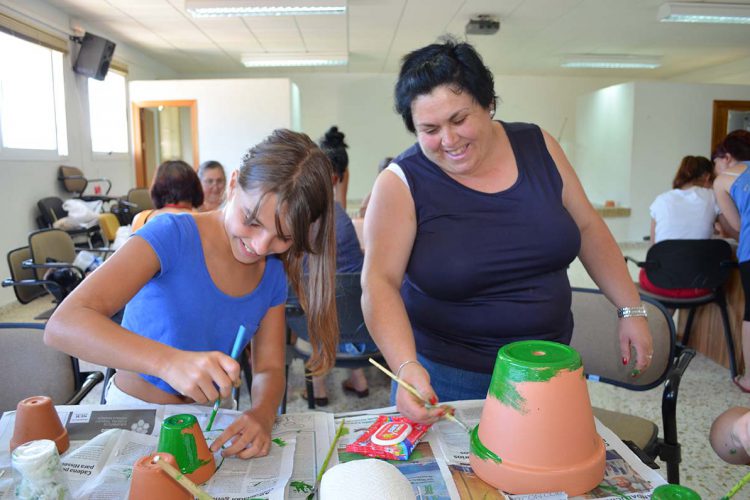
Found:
[130,78,293,174]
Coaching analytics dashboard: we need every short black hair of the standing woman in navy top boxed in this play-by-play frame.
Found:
[395,38,497,133]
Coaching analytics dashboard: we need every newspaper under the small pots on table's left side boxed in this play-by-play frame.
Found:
[0,405,333,499]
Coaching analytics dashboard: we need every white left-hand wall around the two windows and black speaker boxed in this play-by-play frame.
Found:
[0,0,174,304]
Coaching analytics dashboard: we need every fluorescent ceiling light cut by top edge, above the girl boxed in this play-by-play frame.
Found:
[185,0,346,17]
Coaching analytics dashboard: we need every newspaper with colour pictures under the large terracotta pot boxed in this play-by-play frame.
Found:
[335,400,666,500]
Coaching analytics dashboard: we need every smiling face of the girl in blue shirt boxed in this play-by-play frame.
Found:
[224,172,292,264]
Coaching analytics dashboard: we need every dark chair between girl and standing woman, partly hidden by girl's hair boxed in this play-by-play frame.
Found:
[284,273,383,410]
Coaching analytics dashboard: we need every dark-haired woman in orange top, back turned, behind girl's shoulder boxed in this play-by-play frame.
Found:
[131,160,203,231]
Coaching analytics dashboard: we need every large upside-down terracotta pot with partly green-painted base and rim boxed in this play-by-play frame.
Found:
[469,340,605,496]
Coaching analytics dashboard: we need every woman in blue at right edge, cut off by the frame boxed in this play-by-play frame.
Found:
[714,130,750,392]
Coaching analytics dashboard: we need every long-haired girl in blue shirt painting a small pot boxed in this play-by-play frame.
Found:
[45,130,338,458]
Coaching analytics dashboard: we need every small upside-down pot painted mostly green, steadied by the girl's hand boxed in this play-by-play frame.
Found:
[157,414,216,484]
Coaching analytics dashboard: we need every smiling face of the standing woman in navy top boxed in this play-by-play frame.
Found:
[411,85,500,176]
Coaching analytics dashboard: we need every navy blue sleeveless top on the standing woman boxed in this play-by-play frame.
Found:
[400,122,581,373]
